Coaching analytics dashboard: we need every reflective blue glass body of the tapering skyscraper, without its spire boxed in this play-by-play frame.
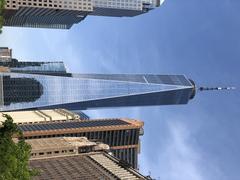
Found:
[0,73,194,111]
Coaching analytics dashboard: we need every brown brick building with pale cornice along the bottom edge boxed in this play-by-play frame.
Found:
[30,152,148,180]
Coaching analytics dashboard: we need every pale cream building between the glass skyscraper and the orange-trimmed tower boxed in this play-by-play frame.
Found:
[0,109,81,124]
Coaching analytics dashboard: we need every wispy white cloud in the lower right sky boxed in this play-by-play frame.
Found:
[159,122,204,180]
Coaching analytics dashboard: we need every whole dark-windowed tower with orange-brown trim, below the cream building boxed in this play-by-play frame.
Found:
[18,119,143,168]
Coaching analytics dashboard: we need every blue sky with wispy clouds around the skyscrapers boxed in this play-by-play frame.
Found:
[0,0,240,180]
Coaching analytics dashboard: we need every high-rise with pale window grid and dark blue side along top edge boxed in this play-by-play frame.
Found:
[4,0,164,29]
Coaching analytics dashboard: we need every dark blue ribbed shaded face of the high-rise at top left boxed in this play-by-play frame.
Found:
[4,7,89,29]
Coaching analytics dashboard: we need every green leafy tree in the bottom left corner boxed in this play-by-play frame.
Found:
[0,114,38,180]
